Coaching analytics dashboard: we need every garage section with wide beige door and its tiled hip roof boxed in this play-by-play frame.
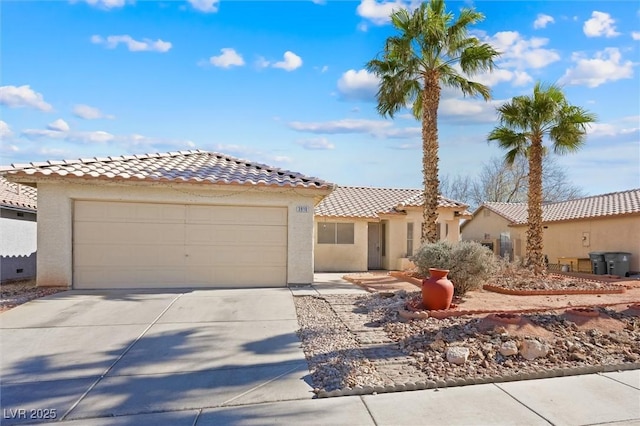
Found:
[0,150,333,289]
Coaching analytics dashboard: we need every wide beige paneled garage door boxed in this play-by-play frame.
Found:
[73,201,287,289]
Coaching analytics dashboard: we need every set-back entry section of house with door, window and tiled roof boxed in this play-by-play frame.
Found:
[314,186,471,272]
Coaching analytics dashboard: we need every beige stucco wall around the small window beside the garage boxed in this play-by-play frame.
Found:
[313,218,369,272]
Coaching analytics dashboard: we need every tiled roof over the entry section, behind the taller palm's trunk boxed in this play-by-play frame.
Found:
[315,186,468,219]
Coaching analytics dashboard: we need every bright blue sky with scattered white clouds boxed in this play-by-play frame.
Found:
[0,0,640,194]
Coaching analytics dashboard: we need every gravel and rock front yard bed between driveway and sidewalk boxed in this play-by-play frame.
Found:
[295,291,640,397]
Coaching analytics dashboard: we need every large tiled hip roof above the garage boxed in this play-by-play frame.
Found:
[0,150,333,189]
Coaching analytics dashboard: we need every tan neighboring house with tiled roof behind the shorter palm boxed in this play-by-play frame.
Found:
[461,189,640,271]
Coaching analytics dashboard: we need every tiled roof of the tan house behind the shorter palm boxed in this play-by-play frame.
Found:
[482,188,640,225]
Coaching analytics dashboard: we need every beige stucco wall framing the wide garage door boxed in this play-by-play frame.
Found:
[37,180,318,286]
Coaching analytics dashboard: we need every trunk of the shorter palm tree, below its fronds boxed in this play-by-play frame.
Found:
[527,137,546,275]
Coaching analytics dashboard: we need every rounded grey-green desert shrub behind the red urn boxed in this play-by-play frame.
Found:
[411,241,497,296]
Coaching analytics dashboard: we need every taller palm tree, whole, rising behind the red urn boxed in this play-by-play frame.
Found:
[366,0,499,243]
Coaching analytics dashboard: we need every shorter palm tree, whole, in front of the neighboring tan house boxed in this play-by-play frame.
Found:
[488,82,596,274]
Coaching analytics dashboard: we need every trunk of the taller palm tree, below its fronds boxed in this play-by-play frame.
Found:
[421,71,440,244]
